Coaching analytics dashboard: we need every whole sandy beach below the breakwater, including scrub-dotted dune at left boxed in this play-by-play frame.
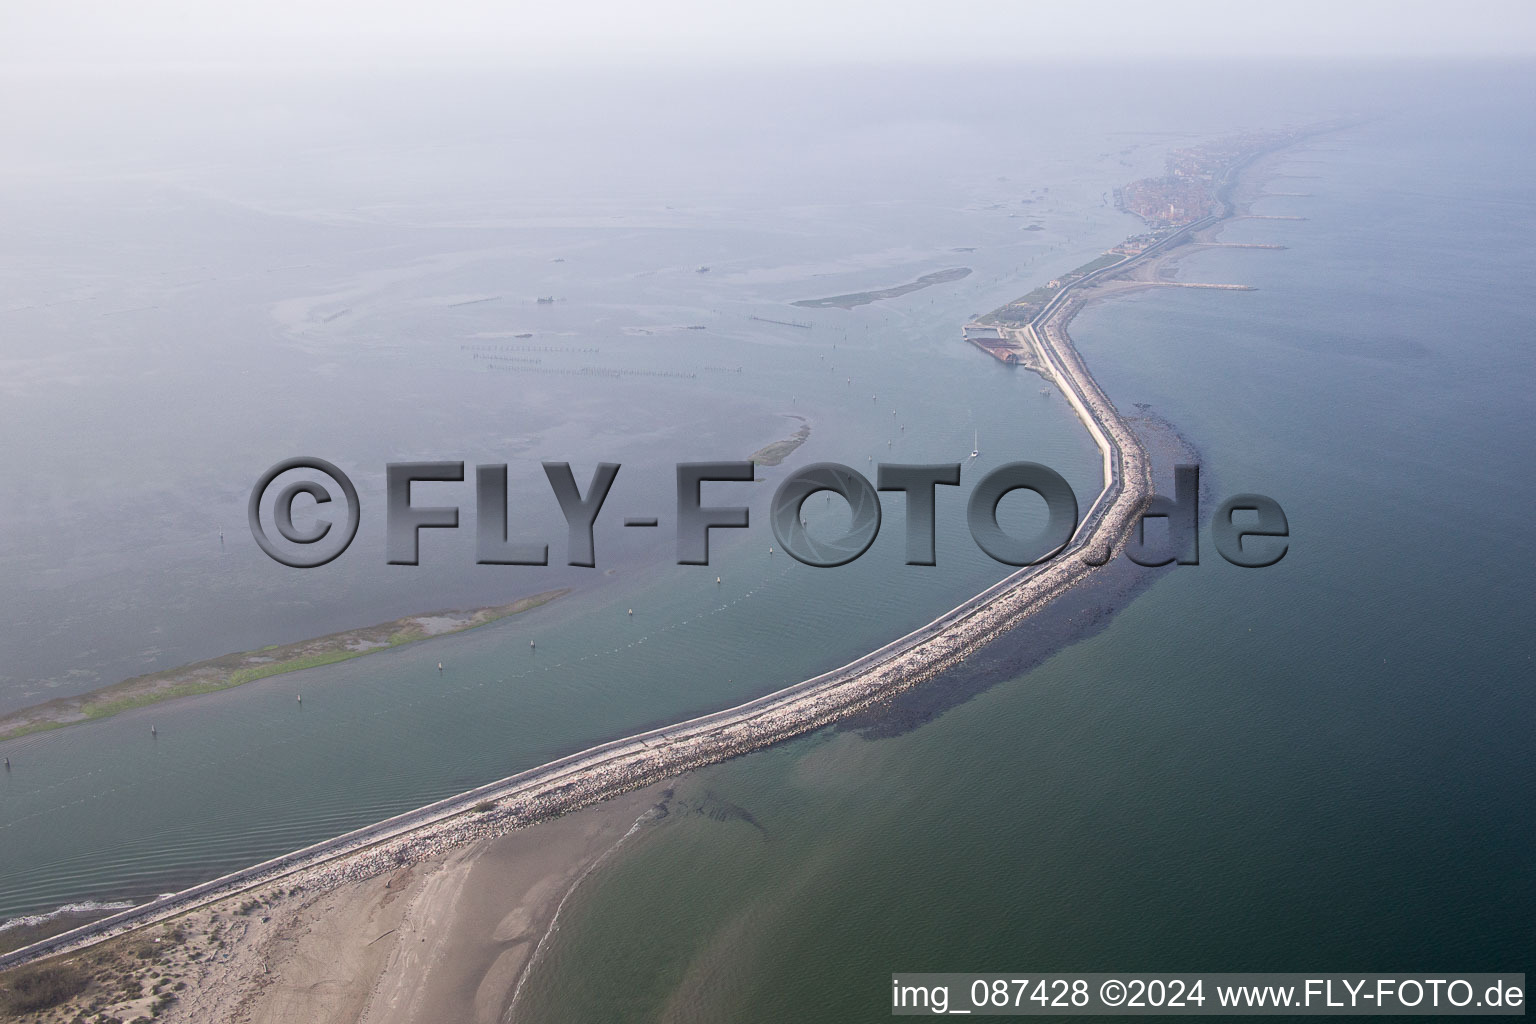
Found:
[8,786,668,1024]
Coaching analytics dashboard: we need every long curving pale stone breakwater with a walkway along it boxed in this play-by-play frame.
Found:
[0,251,1150,967]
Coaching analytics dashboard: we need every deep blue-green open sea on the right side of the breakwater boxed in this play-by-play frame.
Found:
[509,97,1536,1021]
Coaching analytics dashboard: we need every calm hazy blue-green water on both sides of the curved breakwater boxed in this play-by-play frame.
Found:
[0,62,1536,1000]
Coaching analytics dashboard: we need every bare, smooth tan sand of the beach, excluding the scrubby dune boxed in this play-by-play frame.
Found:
[228,786,665,1024]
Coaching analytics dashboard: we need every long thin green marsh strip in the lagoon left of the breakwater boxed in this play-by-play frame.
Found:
[0,586,571,743]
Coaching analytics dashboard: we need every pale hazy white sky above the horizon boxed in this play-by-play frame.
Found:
[0,0,1536,66]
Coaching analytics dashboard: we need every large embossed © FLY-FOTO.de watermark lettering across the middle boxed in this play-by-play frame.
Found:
[247,456,1290,568]
